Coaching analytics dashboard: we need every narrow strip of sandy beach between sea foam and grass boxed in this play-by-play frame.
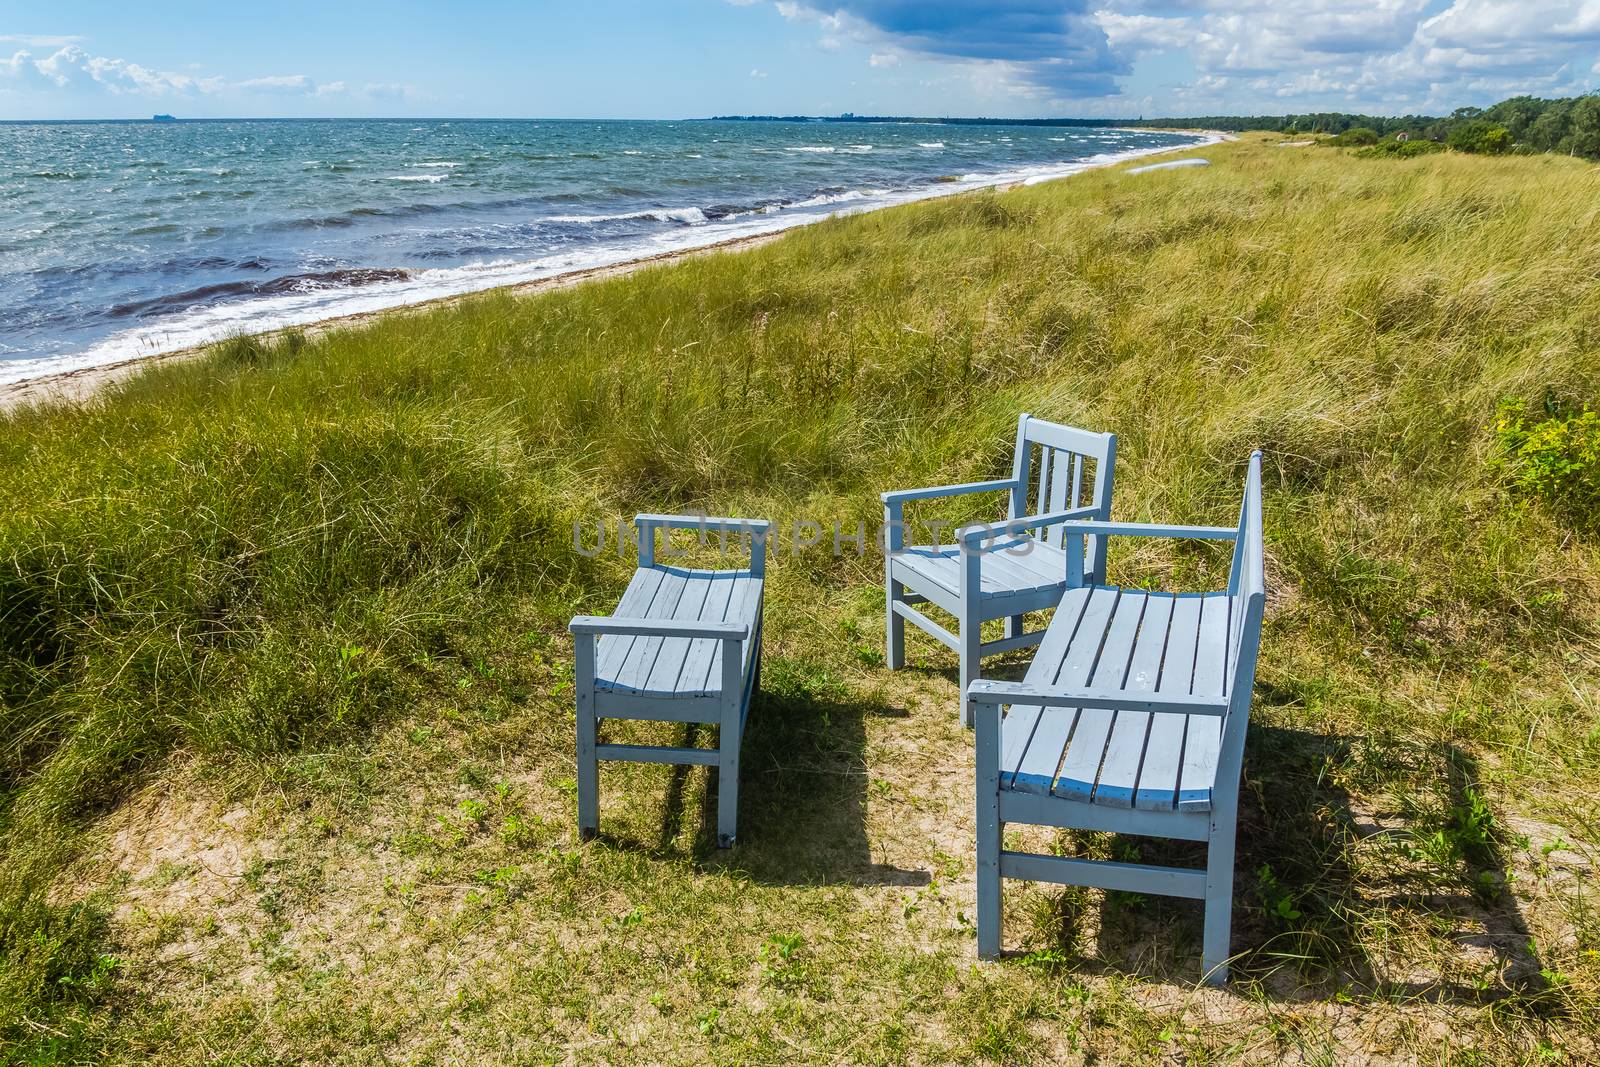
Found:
[0,130,1238,414]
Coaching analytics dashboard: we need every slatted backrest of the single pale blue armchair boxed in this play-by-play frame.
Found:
[1006,414,1117,584]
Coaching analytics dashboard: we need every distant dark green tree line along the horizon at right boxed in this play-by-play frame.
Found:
[717,94,1600,160]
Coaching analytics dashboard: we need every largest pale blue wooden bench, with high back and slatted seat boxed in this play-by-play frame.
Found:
[968,453,1266,984]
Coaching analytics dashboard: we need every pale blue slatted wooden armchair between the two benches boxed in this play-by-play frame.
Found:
[882,414,1117,726]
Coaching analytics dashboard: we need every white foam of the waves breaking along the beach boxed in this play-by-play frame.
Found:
[0,136,1218,384]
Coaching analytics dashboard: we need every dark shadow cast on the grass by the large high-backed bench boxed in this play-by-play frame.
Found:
[1032,686,1555,1013]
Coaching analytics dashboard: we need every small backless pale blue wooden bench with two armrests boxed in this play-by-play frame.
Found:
[568,515,768,848]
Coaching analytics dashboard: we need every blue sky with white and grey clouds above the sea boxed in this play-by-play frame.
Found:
[0,0,1600,118]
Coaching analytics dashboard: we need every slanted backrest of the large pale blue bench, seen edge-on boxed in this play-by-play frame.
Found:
[1216,453,1267,792]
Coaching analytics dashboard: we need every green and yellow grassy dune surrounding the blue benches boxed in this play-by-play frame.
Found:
[0,139,1600,1062]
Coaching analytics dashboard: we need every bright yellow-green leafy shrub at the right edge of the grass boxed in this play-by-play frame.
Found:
[1494,400,1600,533]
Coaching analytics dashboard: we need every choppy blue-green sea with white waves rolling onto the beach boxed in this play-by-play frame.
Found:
[0,120,1205,382]
